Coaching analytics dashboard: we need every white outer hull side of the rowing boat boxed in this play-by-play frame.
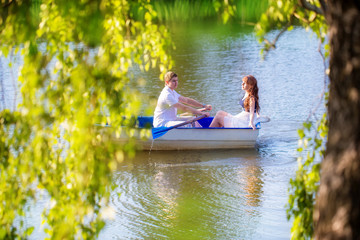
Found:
[117,128,259,150]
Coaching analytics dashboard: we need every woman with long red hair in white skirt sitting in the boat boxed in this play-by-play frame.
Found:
[209,75,260,130]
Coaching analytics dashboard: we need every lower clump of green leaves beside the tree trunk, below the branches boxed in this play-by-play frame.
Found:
[287,104,328,239]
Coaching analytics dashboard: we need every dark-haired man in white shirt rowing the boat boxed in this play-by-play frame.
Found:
[153,72,212,127]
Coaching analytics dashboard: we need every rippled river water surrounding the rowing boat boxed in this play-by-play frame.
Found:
[0,22,324,239]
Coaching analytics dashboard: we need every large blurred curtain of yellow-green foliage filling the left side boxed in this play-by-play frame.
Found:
[0,0,234,239]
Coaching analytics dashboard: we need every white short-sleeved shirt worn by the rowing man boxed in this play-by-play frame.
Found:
[153,86,181,127]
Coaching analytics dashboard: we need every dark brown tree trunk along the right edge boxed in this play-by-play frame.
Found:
[314,0,360,239]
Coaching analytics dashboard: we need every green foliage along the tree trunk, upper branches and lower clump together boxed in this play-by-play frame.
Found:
[255,0,329,239]
